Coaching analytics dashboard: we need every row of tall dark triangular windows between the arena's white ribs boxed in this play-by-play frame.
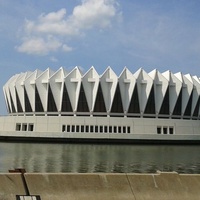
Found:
[6,84,200,117]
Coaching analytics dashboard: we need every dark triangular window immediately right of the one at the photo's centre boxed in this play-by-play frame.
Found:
[111,83,124,113]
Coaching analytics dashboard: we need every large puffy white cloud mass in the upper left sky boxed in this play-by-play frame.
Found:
[16,0,118,55]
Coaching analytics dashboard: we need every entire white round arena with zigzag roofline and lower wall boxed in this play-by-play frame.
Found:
[0,67,200,143]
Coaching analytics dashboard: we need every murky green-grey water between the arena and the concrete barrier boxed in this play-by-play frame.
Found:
[0,143,200,174]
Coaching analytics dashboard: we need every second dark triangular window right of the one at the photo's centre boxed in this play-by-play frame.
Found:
[128,84,140,113]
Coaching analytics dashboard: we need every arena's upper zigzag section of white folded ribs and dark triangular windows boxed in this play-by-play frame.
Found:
[3,67,200,119]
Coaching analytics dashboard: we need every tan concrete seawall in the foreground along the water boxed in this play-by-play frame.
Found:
[0,172,200,200]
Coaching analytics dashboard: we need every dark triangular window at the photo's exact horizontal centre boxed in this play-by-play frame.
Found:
[94,83,106,112]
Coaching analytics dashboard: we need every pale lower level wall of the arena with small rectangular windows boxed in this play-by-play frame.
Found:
[0,116,200,141]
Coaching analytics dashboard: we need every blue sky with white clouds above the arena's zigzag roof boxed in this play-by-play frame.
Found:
[0,0,200,115]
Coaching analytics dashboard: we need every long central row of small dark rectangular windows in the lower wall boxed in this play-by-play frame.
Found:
[62,125,131,133]
